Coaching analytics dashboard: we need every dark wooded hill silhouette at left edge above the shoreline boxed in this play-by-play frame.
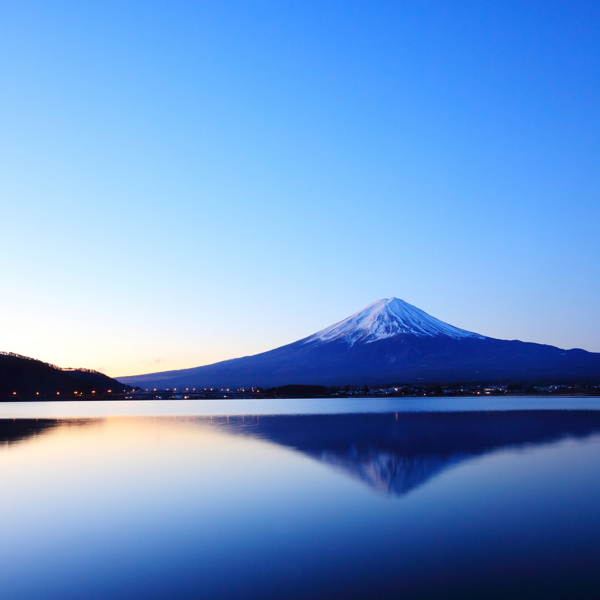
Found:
[0,352,131,401]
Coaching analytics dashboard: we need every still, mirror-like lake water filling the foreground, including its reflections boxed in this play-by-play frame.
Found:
[0,398,600,600]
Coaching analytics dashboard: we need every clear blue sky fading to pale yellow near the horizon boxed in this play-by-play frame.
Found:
[0,0,600,375]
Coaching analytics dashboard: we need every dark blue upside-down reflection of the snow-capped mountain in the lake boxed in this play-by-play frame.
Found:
[213,411,600,495]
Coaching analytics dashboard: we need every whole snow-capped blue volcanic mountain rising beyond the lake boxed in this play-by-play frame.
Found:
[117,298,600,389]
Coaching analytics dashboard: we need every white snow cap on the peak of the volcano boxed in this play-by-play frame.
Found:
[305,298,485,346]
